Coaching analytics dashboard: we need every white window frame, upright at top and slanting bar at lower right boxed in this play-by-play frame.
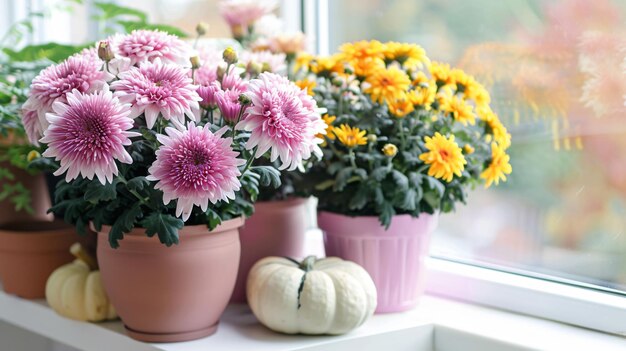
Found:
[298,0,626,336]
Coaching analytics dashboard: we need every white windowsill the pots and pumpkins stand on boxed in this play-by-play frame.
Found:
[0,286,626,351]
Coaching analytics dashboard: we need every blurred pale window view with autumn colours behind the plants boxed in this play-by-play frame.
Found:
[0,0,626,293]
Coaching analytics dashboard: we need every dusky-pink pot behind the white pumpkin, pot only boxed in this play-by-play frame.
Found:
[231,198,307,303]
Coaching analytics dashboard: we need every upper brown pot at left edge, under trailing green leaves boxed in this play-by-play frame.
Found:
[0,162,53,225]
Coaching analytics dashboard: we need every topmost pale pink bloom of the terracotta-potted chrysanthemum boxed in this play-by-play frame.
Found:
[110,29,191,65]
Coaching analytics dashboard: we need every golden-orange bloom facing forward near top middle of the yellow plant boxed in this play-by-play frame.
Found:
[364,67,411,103]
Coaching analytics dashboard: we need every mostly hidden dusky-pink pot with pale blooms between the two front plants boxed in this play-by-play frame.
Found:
[212,0,310,302]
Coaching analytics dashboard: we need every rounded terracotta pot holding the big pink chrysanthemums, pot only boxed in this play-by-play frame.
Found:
[98,218,243,342]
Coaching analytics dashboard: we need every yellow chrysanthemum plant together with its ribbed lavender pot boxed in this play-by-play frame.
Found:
[300,41,511,313]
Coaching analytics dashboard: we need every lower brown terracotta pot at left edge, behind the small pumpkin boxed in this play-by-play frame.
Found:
[0,221,77,299]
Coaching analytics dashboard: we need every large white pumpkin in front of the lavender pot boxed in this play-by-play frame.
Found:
[247,256,376,335]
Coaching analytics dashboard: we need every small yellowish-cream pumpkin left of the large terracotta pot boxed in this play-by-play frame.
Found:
[46,243,117,322]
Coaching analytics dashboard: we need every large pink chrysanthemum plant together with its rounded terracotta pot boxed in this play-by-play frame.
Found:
[25,30,325,342]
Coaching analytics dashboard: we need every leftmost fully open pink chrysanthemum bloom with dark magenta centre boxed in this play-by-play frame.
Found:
[40,85,139,184]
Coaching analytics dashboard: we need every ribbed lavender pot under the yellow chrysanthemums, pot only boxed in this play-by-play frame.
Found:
[317,211,438,313]
